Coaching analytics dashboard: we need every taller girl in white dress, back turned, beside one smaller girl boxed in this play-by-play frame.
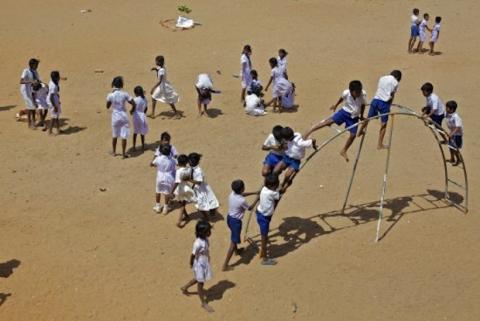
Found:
[105,76,135,159]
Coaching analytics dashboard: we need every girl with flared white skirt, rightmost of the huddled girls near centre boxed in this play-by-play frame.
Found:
[188,153,220,221]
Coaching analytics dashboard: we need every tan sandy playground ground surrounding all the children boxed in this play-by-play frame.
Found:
[0,0,480,321]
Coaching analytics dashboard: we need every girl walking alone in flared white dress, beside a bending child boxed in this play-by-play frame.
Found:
[150,56,179,118]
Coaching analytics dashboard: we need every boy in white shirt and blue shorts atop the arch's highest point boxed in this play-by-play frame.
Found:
[357,70,402,149]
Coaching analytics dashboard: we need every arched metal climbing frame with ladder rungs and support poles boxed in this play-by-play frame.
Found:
[244,104,468,242]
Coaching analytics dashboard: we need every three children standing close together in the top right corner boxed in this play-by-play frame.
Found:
[408,8,442,56]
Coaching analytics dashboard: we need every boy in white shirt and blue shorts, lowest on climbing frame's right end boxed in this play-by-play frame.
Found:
[447,100,463,166]
